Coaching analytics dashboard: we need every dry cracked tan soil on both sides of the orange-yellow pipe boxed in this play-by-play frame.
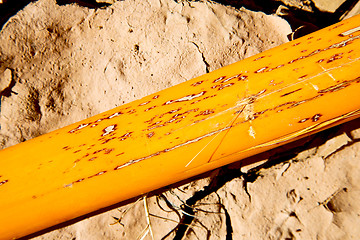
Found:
[0,0,360,240]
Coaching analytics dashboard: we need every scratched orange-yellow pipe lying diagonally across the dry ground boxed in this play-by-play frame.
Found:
[0,14,360,239]
